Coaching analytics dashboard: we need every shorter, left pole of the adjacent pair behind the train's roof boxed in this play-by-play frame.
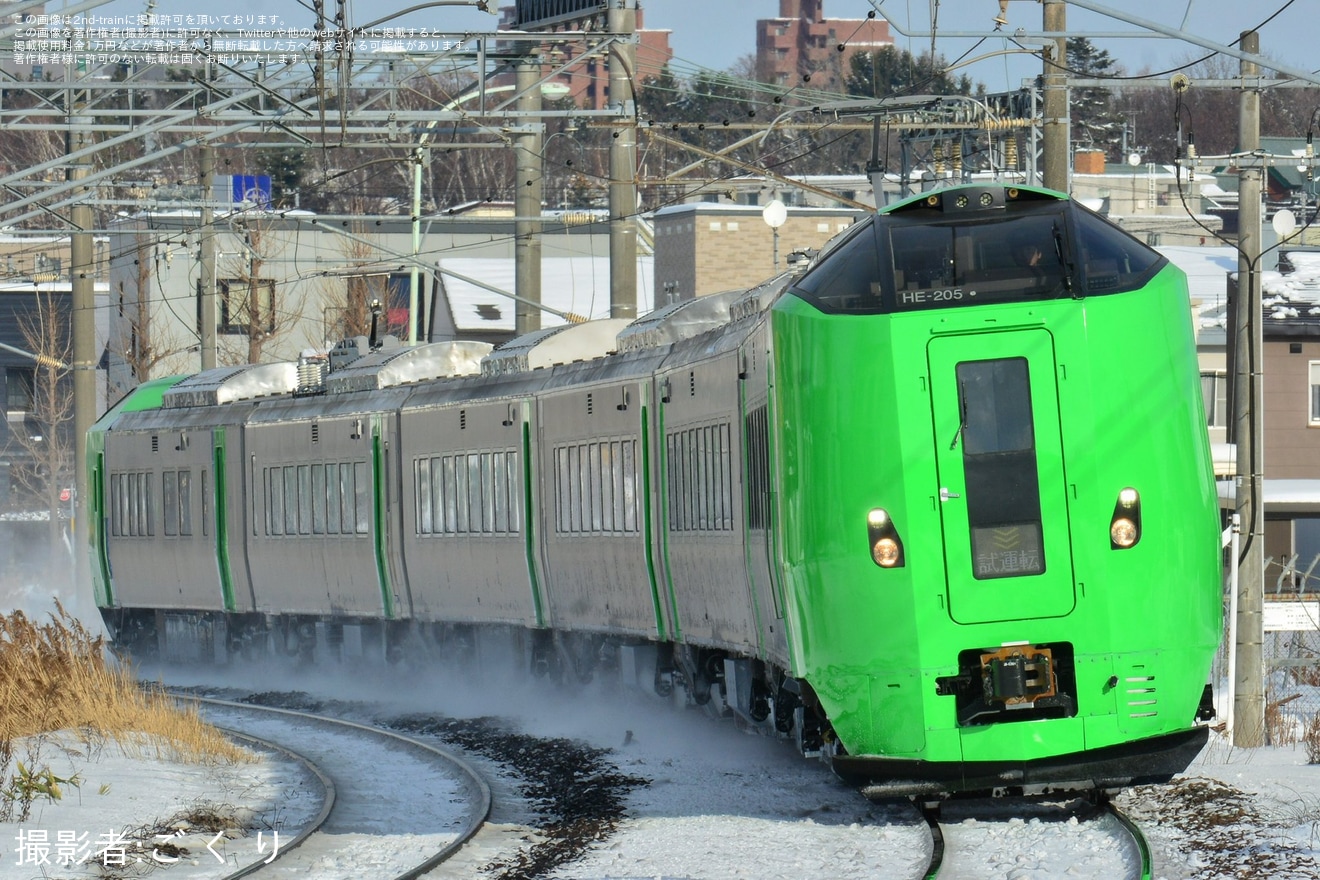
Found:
[513,49,545,336]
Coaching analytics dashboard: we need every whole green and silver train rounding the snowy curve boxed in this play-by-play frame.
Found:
[88,185,1221,796]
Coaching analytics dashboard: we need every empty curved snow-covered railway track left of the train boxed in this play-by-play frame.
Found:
[176,693,491,880]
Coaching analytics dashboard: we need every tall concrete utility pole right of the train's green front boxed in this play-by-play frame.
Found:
[1230,30,1265,748]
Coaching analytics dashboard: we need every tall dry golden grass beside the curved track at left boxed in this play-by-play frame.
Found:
[0,603,251,763]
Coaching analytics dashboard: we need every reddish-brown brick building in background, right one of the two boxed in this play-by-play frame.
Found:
[756,0,894,90]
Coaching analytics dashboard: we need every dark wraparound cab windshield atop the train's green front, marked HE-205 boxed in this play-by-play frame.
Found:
[795,201,1164,314]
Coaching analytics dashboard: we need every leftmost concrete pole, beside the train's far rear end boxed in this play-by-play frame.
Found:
[69,110,96,598]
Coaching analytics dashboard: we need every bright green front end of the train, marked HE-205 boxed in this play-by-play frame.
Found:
[772,186,1222,794]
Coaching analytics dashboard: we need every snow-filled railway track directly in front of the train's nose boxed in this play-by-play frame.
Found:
[916,796,1152,880]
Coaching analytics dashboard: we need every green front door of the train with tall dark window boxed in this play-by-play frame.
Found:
[927,329,1074,624]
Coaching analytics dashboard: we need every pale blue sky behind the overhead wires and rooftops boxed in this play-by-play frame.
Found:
[66,0,1320,91]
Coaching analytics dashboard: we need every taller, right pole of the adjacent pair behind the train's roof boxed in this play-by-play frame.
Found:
[609,0,638,318]
